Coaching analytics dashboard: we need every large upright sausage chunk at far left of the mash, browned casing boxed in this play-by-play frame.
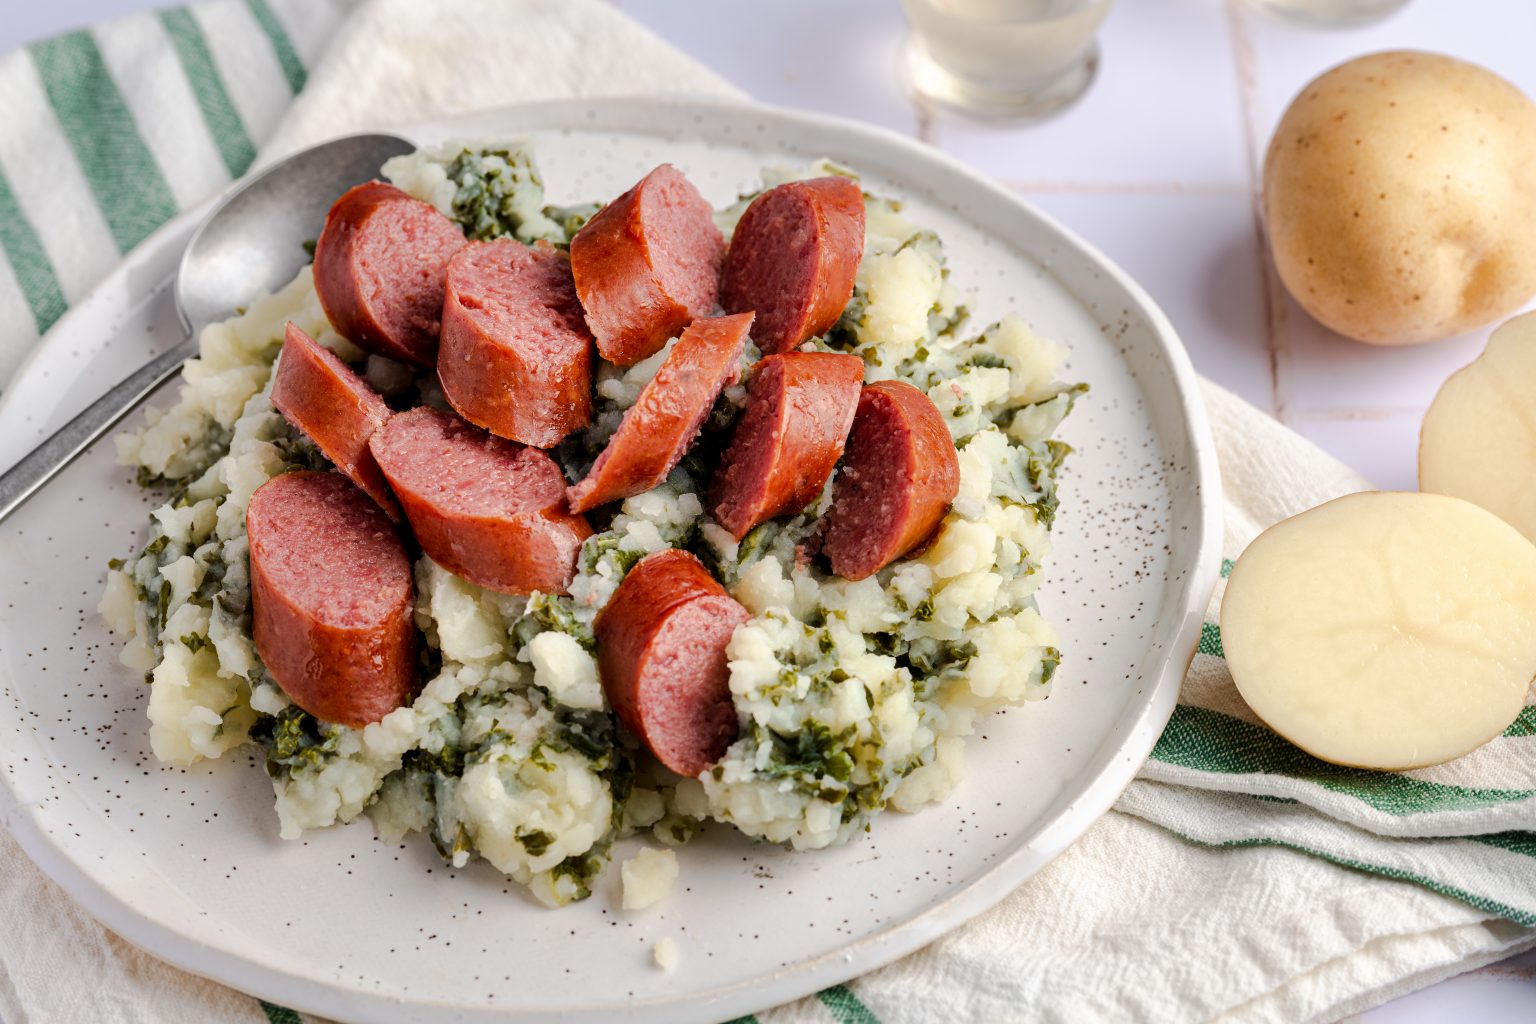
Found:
[246,473,416,728]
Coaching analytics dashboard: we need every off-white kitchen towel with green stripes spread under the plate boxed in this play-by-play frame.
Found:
[0,0,1536,1024]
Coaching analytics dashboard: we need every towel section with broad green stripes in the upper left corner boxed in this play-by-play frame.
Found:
[0,0,352,388]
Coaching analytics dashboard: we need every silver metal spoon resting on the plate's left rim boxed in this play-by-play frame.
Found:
[0,134,415,520]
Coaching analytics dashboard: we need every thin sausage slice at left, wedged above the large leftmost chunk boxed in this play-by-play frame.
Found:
[272,322,399,522]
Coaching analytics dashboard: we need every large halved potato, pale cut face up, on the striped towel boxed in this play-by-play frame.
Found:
[1221,491,1536,769]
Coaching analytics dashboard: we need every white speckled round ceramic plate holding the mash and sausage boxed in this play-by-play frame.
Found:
[0,100,1221,1021]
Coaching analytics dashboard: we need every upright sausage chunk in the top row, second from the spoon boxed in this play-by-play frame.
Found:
[438,238,591,448]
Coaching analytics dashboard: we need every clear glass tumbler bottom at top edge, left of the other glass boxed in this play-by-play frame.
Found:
[902,0,1114,120]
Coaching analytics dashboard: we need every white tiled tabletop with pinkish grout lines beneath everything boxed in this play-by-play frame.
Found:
[0,0,1536,1024]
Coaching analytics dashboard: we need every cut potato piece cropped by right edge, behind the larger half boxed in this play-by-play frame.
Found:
[1419,313,1536,540]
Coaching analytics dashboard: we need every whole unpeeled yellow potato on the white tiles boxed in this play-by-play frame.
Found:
[1264,51,1536,345]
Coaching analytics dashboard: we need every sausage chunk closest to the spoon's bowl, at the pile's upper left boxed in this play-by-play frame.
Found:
[315,181,464,367]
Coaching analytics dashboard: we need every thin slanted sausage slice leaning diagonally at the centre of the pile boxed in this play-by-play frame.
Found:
[570,313,753,511]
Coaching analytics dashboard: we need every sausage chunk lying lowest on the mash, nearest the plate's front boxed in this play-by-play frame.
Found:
[593,548,751,777]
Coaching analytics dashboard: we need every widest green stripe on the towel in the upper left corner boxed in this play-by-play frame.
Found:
[28,31,177,253]
